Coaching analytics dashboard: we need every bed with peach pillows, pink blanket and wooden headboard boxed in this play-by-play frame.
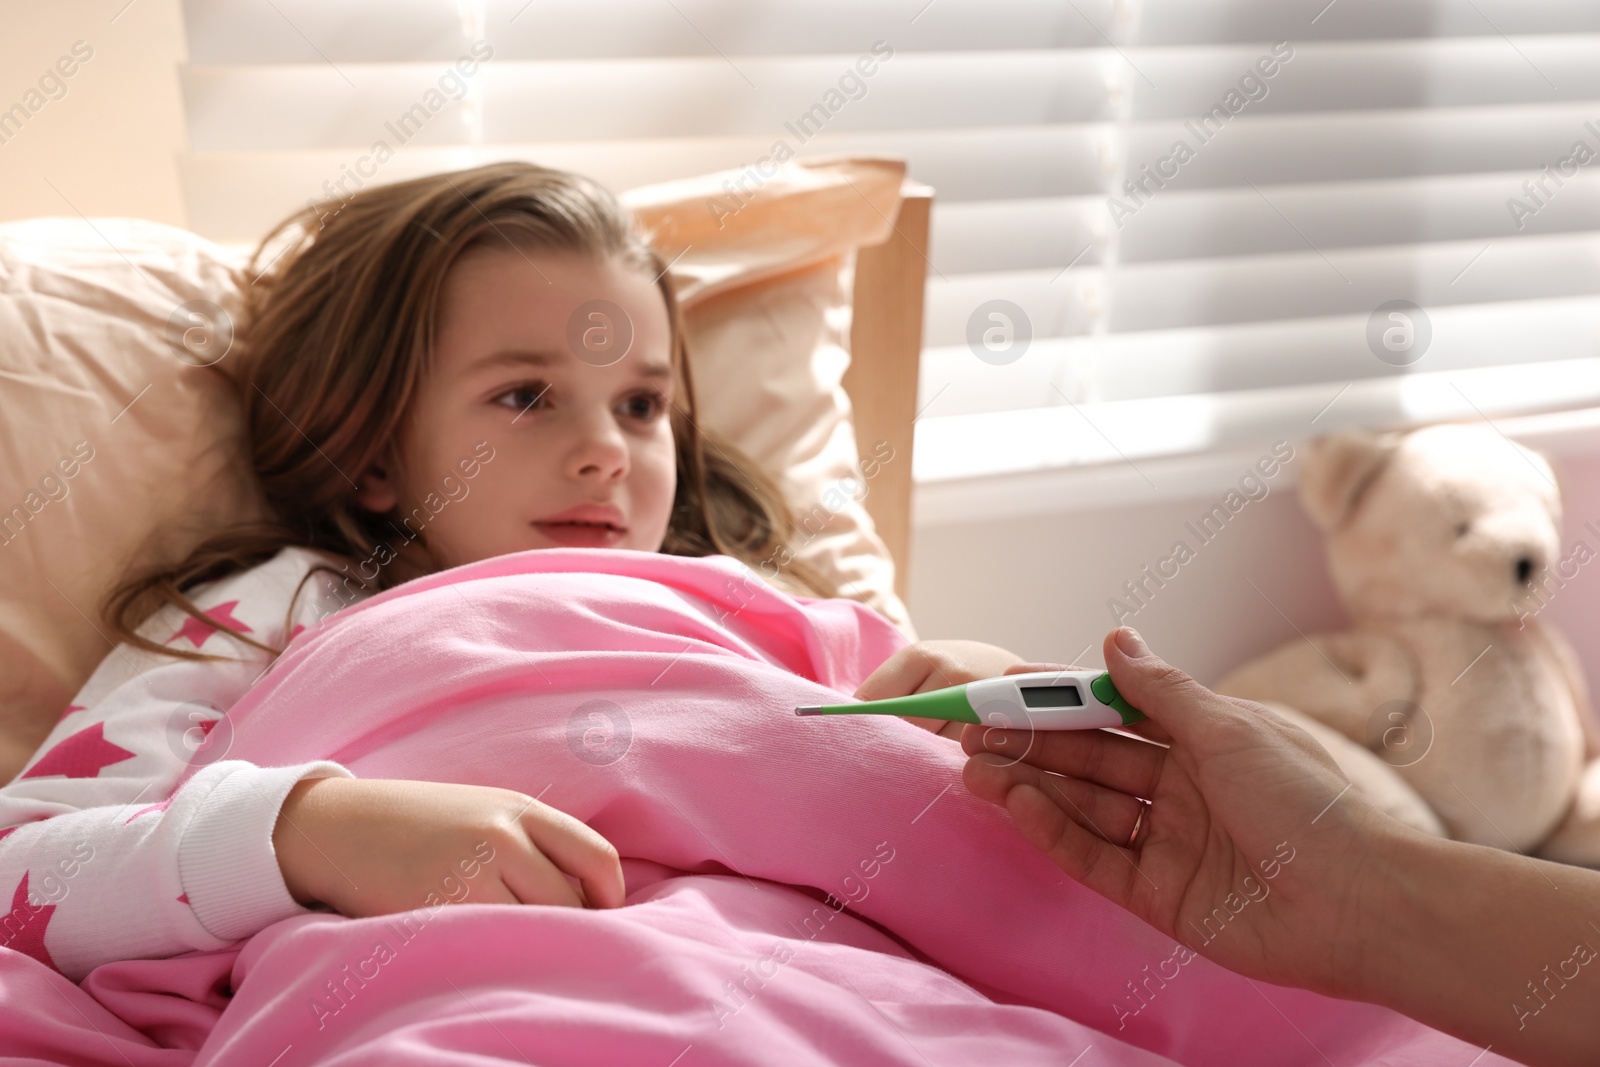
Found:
[0,160,1494,1067]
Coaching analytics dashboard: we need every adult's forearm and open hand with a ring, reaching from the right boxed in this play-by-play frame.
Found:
[962,629,1600,1067]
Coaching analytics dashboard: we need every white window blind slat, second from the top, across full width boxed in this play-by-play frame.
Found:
[182,35,1600,154]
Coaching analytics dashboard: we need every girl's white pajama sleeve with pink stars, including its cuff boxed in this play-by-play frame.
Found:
[0,550,347,979]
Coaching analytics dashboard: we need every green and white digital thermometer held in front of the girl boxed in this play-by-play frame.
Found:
[795,670,1144,729]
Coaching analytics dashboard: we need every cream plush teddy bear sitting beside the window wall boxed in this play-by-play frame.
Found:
[1216,424,1600,867]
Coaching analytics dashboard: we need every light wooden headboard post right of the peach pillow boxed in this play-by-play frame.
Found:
[845,181,933,600]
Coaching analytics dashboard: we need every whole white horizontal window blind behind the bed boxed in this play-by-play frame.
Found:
[181,0,1600,482]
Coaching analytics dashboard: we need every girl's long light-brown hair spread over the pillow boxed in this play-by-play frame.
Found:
[104,163,838,659]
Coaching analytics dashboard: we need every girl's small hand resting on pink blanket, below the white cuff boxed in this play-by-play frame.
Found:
[272,777,624,917]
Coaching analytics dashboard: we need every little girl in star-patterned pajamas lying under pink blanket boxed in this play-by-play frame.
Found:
[0,163,1016,979]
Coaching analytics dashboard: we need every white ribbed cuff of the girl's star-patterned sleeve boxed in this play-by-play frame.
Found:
[174,760,354,941]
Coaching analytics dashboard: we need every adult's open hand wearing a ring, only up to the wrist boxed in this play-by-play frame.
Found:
[962,630,1402,997]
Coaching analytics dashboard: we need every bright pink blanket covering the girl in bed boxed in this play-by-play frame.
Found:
[0,549,1506,1067]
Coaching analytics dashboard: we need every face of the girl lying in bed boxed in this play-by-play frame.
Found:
[357,245,677,566]
